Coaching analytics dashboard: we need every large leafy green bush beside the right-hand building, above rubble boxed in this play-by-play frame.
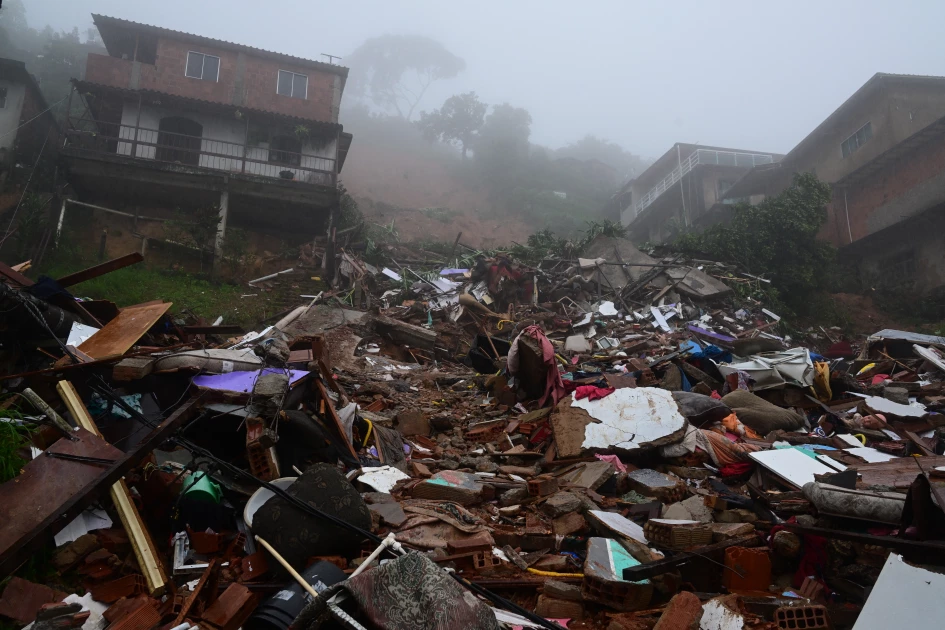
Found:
[673,173,835,313]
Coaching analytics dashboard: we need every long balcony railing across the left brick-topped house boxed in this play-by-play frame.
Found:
[65,119,336,186]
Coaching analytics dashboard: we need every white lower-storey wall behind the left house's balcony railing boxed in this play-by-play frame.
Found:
[117,101,338,183]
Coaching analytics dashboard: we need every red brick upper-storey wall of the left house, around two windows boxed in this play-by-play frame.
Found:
[85,38,337,122]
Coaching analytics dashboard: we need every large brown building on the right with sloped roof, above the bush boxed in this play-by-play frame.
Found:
[727,73,945,295]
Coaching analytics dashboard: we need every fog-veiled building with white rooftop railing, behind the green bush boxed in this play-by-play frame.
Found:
[615,143,781,243]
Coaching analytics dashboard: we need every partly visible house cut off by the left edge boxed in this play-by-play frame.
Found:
[0,59,58,178]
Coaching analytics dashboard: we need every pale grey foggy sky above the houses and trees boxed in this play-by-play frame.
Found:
[24,0,945,157]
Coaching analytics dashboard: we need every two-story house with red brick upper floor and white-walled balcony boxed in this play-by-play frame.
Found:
[62,15,352,253]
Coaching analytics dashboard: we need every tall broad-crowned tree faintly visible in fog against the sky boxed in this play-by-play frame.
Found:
[345,35,466,120]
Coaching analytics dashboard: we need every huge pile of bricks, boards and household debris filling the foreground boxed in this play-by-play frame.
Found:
[0,243,945,630]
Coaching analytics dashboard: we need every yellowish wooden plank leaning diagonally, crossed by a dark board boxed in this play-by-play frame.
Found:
[56,381,167,597]
